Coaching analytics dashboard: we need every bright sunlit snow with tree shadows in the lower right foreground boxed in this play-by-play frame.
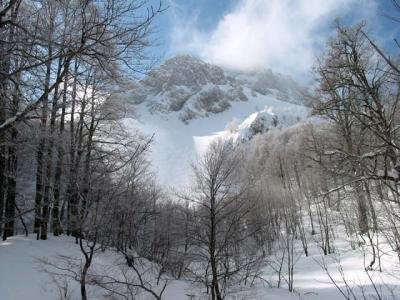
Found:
[260,239,400,300]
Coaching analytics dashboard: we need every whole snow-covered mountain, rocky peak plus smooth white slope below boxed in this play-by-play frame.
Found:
[124,56,309,187]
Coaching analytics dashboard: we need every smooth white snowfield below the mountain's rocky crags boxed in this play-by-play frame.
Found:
[124,89,309,187]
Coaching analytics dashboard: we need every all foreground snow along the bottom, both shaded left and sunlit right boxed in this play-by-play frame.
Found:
[0,227,400,300]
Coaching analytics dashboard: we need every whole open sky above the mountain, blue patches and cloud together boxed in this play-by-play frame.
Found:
[151,0,400,78]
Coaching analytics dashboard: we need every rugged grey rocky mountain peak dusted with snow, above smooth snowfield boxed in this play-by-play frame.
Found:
[132,55,308,124]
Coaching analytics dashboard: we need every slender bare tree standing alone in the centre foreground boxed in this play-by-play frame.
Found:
[186,141,261,299]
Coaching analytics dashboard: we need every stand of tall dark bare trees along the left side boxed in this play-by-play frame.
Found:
[0,1,161,240]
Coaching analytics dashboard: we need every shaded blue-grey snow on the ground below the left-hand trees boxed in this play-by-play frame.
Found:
[0,234,189,300]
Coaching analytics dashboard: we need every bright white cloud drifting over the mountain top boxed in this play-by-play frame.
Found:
[171,0,375,77]
